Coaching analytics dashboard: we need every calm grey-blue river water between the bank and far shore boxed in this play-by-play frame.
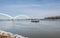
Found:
[0,20,60,38]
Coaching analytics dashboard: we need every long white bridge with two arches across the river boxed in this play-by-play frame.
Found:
[0,13,40,21]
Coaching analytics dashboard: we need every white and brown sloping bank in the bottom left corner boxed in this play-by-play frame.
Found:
[0,30,28,38]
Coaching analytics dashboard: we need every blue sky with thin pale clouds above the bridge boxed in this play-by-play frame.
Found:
[0,0,60,18]
